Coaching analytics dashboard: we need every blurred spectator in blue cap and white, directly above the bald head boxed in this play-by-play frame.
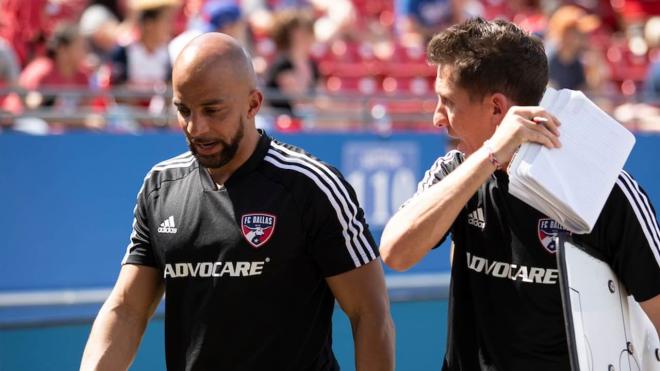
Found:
[168,0,249,62]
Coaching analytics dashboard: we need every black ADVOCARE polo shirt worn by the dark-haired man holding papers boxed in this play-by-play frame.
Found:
[408,151,660,371]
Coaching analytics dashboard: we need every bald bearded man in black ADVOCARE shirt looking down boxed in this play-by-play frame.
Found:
[81,33,394,371]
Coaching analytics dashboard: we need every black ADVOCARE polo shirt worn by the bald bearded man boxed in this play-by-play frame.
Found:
[123,133,378,371]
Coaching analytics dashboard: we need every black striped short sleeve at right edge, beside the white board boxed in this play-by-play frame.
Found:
[575,171,660,301]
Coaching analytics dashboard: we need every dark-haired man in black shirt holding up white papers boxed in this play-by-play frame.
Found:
[381,18,660,371]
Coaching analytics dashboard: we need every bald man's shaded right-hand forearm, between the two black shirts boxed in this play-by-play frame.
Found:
[351,314,394,371]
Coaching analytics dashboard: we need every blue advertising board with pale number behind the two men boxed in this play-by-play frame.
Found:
[0,133,660,292]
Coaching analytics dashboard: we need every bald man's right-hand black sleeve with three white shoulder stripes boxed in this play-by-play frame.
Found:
[304,164,379,277]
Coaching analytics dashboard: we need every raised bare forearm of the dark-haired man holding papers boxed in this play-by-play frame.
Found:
[380,149,495,270]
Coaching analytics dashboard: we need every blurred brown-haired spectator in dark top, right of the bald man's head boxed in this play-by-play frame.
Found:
[266,10,320,116]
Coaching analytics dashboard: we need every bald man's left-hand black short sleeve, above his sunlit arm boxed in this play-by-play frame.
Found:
[122,180,157,267]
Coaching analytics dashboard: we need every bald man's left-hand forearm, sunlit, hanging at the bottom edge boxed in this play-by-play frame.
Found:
[80,303,147,370]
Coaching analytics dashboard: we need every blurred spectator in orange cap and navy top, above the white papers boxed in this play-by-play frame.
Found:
[547,5,600,90]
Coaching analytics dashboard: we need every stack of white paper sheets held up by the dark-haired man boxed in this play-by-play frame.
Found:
[509,88,635,234]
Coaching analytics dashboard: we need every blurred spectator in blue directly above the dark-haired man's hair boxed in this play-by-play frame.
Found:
[395,0,483,47]
